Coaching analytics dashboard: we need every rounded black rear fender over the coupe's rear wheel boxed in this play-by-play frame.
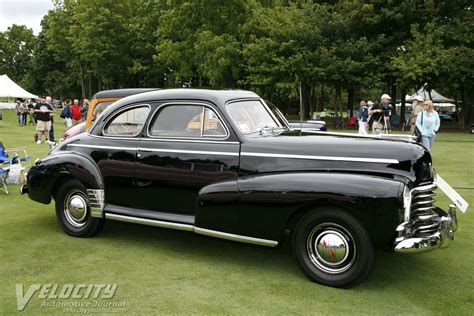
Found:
[27,152,104,204]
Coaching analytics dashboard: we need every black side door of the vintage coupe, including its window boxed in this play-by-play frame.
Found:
[135,102,240,214]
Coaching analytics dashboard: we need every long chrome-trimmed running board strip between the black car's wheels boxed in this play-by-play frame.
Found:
[105,213,278,247]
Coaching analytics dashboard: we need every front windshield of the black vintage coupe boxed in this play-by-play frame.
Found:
[227,100,283,134]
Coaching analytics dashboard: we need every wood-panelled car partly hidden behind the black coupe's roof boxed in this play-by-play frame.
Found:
[64,88,157,140]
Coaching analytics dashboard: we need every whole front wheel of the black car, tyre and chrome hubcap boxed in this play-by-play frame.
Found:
[293,207,375,287]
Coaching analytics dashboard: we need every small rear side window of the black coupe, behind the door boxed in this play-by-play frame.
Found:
[104,106,150,136]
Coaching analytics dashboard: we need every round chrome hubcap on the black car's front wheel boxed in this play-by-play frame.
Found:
[306,223,356,274]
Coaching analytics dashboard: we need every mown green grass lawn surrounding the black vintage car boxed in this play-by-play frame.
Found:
[0,110,474,315]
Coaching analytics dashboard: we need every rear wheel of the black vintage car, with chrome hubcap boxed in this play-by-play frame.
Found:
[55,179,104,237]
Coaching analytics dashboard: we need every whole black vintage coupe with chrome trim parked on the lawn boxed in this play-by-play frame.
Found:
[22,89,457,287]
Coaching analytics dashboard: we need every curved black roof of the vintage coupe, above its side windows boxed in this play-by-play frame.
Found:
[111,88,260,111]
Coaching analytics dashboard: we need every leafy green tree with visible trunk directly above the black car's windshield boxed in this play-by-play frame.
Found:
[244,3,330,118]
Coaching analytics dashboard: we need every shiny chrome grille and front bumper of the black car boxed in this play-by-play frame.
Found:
[394,184,458,253]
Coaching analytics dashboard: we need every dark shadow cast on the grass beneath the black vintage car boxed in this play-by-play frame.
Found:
[90,221,462,289]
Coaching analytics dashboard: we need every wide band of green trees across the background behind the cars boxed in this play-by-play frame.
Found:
[0,0,474,120]
